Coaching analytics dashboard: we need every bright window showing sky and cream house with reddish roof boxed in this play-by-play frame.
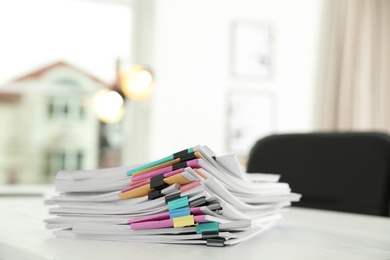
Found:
[0,0,133,185]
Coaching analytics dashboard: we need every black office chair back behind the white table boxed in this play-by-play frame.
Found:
[247,132,390,216]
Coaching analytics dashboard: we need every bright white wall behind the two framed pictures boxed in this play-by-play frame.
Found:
[134,0,323,160]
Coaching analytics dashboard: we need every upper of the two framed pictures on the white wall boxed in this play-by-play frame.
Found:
[231,22,273,79]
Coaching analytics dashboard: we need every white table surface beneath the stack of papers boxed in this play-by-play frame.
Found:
[0,193,390,260]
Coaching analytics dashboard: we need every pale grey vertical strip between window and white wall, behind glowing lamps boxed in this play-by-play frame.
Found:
[122,0,155,165]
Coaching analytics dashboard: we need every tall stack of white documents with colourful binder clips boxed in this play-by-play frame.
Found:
[45,145,300,246]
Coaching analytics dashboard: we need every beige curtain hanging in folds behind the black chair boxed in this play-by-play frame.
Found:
[317,0,390,132]
